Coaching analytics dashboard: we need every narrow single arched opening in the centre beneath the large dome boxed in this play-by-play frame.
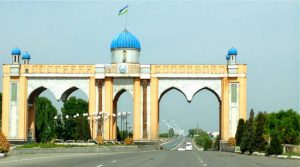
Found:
[113,89,133,141]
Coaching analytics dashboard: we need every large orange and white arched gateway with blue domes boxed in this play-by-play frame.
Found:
[2,30,246,142]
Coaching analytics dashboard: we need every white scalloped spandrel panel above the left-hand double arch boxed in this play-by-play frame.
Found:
[27,78,89,100]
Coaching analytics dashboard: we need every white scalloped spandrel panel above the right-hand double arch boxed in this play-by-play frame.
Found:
[158,78,221,102]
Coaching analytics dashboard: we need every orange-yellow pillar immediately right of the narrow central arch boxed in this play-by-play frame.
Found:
[133,78,141,140]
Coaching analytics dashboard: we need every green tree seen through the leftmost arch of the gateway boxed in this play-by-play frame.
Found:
[35,97,57,143]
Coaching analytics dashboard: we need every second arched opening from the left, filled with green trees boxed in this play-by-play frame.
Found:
[56,87,90,141]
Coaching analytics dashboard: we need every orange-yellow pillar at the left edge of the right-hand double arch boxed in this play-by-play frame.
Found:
[150,77,159,140]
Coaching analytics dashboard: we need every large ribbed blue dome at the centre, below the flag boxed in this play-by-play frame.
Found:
[110,30,141,50]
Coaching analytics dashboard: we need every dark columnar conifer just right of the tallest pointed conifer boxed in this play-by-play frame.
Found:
[254,112,268,151]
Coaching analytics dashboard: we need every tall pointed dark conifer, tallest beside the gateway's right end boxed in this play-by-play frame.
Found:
[240,109,255,154]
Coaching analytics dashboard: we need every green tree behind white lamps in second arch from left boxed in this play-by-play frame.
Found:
[61,97,94,140]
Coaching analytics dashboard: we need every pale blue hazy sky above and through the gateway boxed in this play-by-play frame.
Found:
[0,0,300,131]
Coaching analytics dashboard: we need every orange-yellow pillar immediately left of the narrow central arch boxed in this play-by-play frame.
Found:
[104,77,113,140]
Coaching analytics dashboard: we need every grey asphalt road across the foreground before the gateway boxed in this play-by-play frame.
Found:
[0,144,300,167]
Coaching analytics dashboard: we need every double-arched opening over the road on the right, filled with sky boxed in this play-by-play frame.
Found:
[159,87,221,143]
